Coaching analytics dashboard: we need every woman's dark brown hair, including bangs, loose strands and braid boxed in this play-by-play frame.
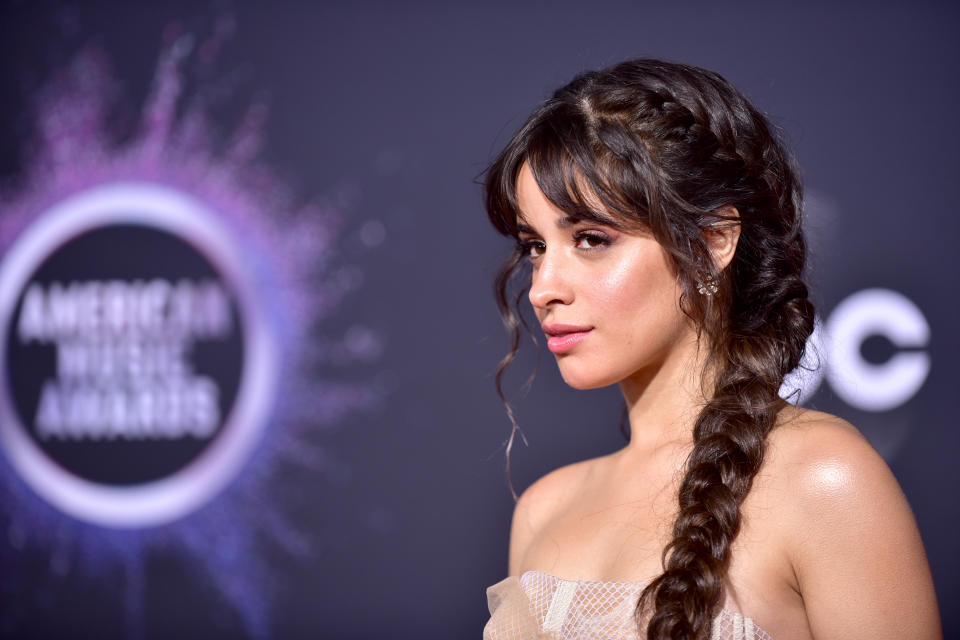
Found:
[485,60,813,640]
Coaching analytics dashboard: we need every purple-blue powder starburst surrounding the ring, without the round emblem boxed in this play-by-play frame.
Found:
[0,19,381,638]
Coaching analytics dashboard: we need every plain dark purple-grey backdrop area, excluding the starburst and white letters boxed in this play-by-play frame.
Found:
[0,1,960,638]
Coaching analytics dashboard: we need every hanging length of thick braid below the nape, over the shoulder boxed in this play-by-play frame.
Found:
[641,300,812,639]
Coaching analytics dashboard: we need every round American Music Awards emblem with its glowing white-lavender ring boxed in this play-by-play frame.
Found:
[0,182,275,527]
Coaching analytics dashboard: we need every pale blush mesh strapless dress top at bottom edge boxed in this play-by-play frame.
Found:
[483,571,772,640]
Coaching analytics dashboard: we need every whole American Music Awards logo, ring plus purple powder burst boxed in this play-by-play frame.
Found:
[0,23,385,638]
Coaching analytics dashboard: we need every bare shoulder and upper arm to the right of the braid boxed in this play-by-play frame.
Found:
[763,407,940,638]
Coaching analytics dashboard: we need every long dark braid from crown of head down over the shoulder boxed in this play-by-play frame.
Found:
[638,67,813,640]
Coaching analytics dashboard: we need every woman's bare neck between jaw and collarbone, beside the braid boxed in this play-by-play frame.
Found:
[620,332,709,456]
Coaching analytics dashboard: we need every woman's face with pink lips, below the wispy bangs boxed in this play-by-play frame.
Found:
[517,164,695,389]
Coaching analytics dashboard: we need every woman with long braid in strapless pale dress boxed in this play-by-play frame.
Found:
[484,60,941,640]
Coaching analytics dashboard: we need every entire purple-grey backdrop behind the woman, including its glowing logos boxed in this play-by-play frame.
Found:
[0,2,960,638]
